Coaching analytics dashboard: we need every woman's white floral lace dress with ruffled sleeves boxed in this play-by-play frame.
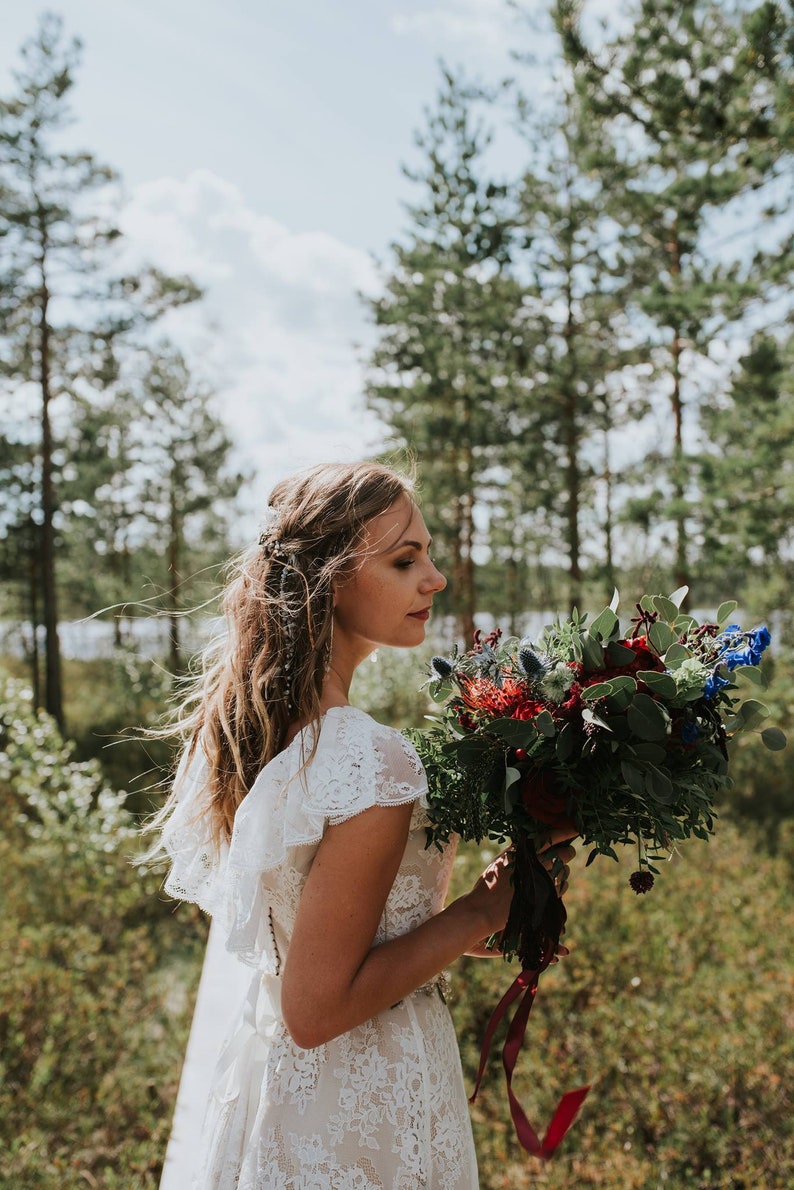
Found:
[158,707,477,1190]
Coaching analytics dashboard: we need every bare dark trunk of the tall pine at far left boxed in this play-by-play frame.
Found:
[38,234,64,731]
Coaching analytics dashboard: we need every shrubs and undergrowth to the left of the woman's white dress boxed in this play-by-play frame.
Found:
[0,683,205,1190]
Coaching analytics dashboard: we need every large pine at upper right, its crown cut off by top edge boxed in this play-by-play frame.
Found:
[555,0,790,595]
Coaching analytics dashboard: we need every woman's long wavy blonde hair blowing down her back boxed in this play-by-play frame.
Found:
[157,462,413,844]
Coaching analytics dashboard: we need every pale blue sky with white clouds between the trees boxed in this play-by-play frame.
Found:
[0,0,590,533]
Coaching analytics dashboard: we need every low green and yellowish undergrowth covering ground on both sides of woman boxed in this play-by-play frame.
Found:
[0,646,794,1190]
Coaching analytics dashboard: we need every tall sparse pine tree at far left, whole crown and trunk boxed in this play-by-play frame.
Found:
[0,14,198,726]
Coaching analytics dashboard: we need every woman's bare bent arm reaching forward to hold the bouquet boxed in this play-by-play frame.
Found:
[281,803,512,1048]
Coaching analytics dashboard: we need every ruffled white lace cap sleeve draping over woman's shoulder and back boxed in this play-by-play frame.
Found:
[162,707,427,973]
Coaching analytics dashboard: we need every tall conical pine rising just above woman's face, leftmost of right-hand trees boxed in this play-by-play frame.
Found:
[368,71,523,641]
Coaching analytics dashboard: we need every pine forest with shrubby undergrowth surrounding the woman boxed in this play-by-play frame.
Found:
[0,0,794,1190]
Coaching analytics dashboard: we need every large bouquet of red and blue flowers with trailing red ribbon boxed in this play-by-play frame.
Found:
[412,588,786,1155]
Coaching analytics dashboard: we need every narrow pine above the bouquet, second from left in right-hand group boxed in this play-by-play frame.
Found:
[517,80,637,608]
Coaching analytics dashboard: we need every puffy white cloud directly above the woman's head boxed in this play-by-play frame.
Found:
[117,170,381,532]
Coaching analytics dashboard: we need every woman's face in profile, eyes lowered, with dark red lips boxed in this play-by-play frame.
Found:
[333,496,446,664]
